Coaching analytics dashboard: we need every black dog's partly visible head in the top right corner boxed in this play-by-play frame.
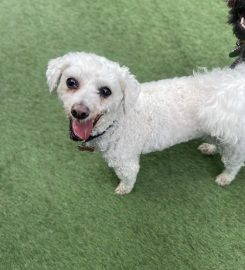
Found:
[227,0,245,40]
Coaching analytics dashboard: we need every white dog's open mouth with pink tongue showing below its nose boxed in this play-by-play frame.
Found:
[69,114,102,141]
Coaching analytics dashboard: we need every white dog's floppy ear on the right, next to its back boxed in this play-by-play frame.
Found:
[121,67,140,113]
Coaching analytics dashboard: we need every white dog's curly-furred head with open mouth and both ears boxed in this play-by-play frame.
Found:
[46,53,140,141]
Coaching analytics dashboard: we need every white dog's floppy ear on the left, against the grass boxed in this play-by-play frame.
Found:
[46,56,67,92]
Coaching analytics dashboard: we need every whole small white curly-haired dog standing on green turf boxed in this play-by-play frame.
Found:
[47,53,245,194]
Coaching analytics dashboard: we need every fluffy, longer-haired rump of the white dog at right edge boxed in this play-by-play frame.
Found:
[197,64,245,143]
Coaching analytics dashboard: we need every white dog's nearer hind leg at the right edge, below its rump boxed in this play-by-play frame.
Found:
[215,144,245,186]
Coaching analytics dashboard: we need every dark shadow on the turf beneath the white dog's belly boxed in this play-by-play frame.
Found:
[132,140,223,196]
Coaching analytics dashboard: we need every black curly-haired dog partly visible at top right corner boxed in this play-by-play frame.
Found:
[227,0,245,68]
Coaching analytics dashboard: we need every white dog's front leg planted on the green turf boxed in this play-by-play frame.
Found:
[114,159,140,195]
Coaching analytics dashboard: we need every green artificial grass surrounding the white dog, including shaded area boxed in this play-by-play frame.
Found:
[0,0,245,270]
